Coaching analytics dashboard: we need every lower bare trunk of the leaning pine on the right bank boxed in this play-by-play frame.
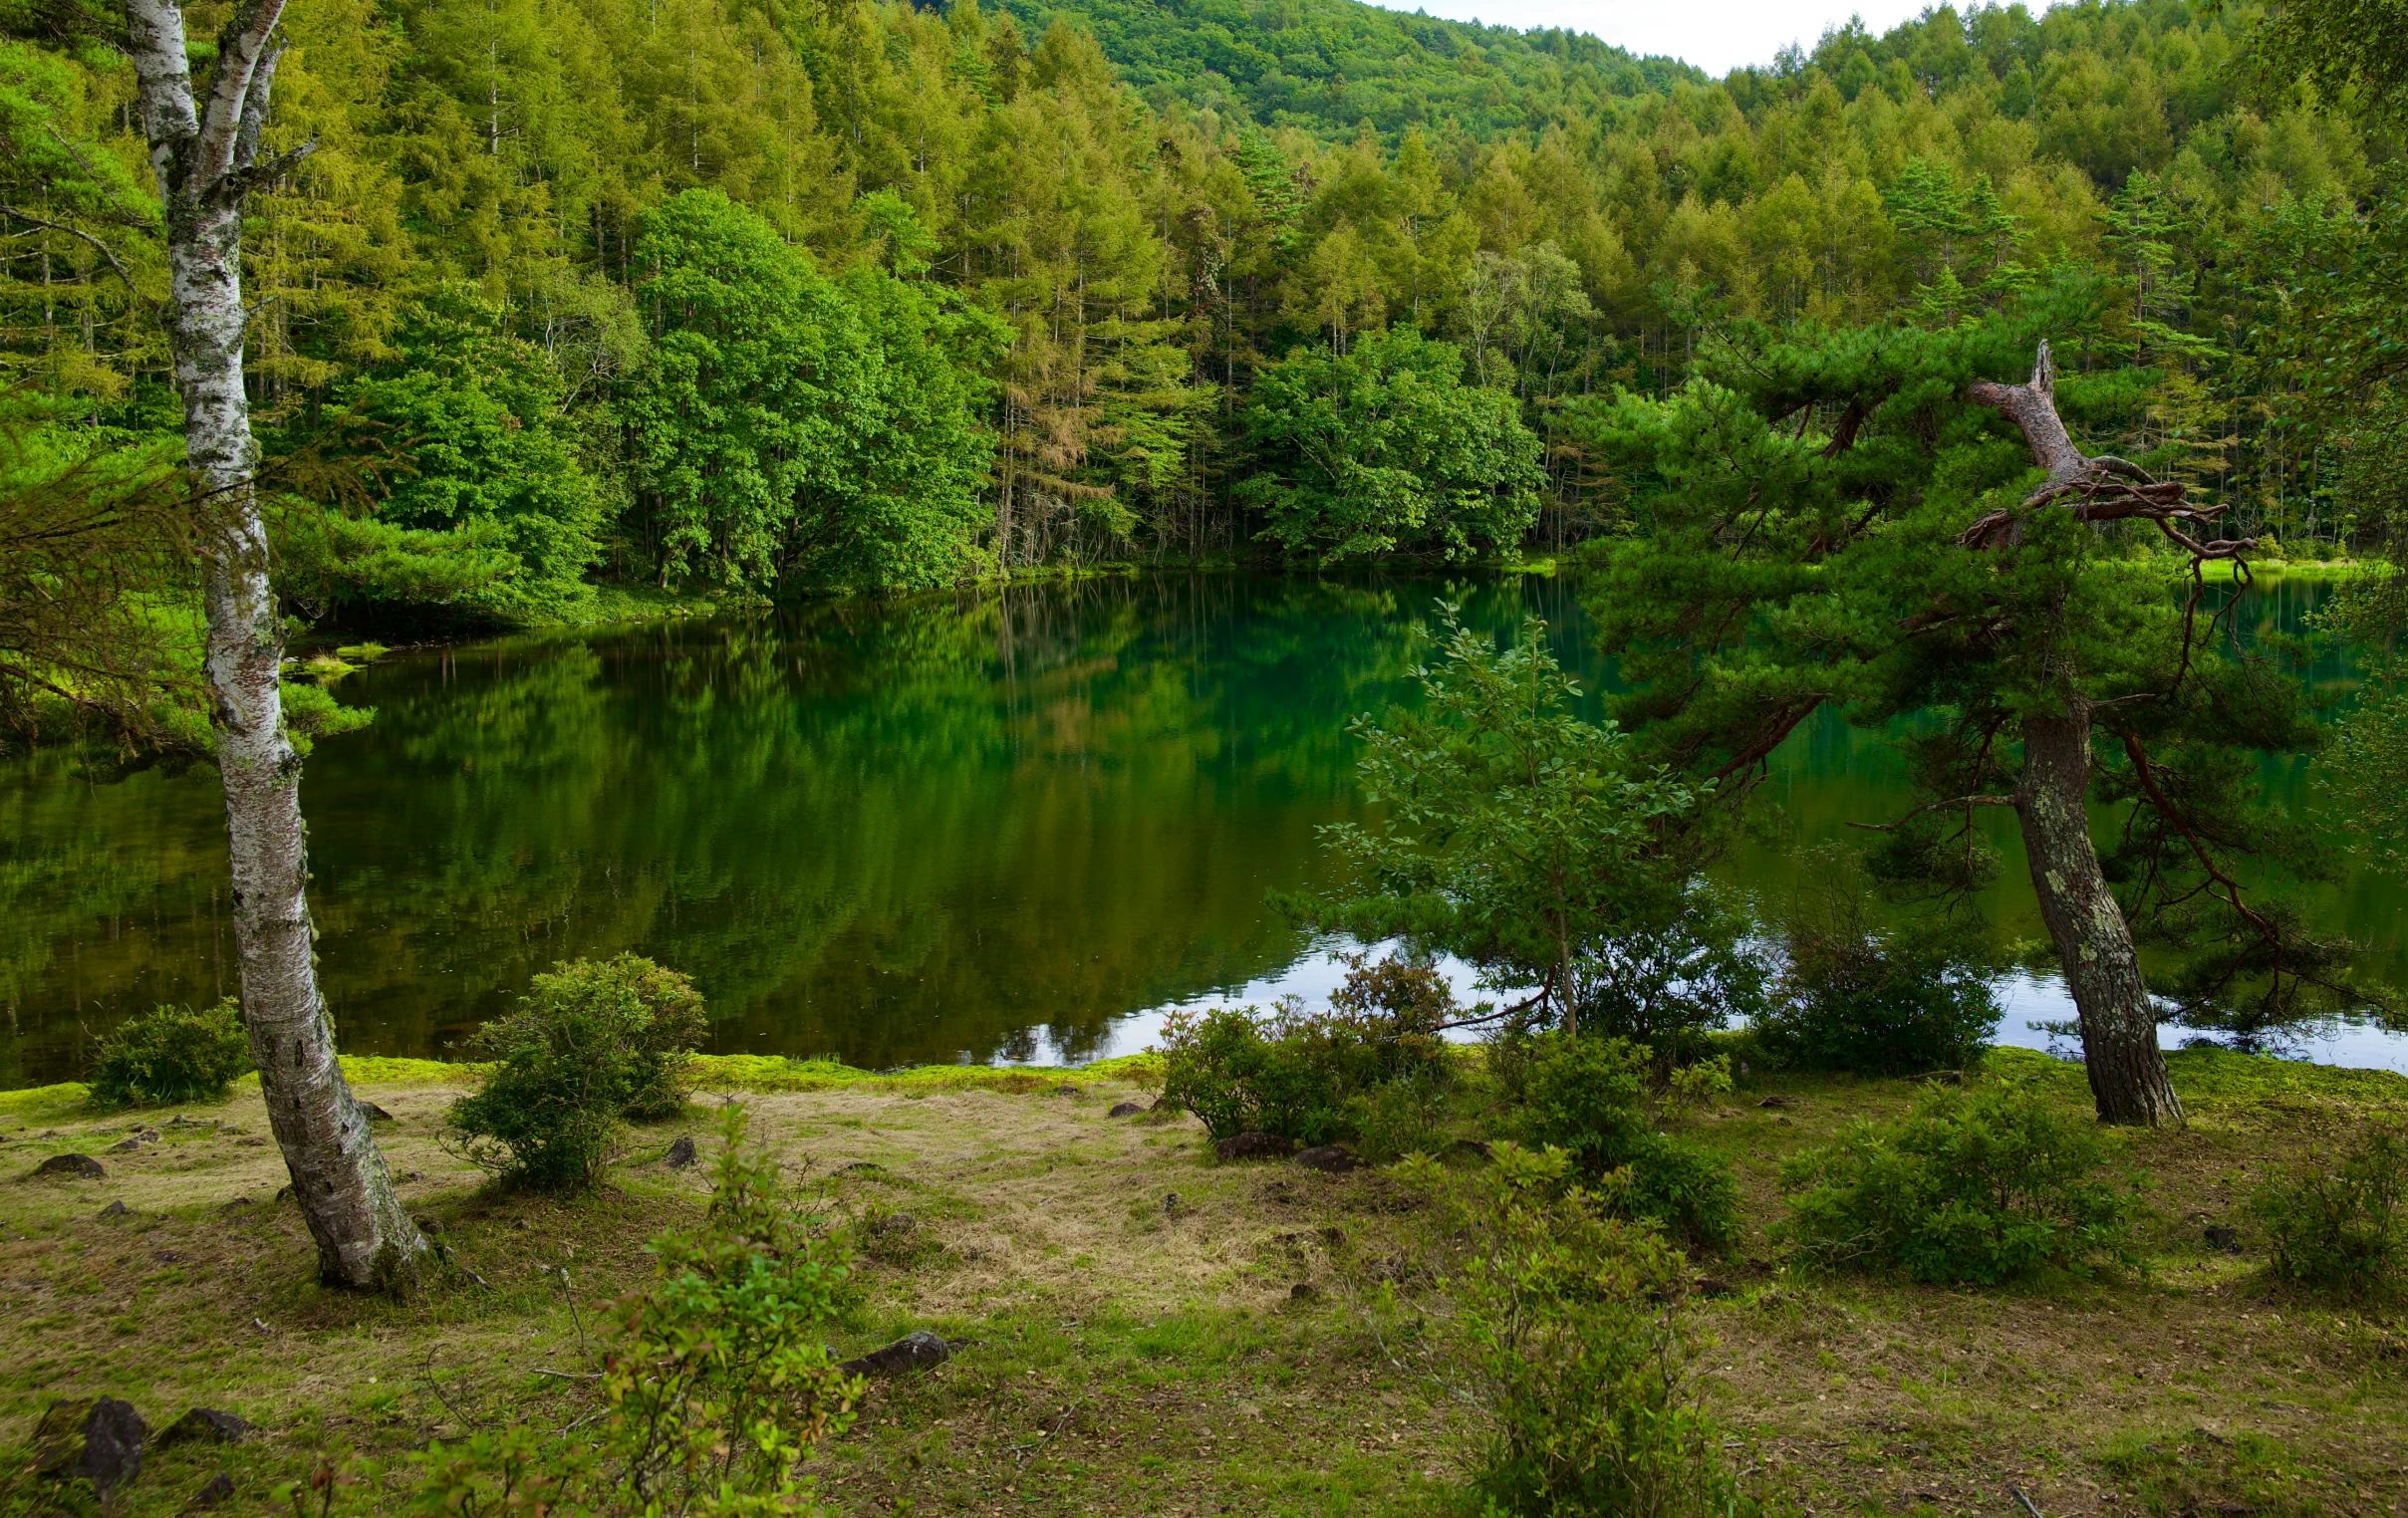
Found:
[2015,705,2182,1126]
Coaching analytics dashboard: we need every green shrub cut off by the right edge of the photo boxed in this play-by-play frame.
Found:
[2249,1129,2408,1297]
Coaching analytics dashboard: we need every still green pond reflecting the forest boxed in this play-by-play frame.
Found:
[0,575,2403,1085]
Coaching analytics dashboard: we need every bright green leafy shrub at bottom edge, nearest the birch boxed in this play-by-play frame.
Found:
[409,1105,862,1518]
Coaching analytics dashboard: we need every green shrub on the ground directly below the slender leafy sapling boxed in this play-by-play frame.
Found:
[1507,1032,1739,1246]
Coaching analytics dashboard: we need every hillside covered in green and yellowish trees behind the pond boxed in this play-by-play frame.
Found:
[0,0,2391,628]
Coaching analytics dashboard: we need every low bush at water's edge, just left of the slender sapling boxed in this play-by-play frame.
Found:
[1163,955,1457,1145]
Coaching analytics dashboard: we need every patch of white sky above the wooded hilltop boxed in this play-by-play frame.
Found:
[1387,0,1994,80]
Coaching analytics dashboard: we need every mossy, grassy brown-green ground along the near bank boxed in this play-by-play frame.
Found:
[0,1051,2408,1518]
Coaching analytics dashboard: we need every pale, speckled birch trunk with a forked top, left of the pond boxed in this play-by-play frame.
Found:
[126,0,426,1292]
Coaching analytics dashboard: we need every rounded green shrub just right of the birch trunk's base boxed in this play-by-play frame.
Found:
[450,955,708,1191]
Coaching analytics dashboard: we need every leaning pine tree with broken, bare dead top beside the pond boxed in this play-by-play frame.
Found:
[1584,291,2350,1124]
